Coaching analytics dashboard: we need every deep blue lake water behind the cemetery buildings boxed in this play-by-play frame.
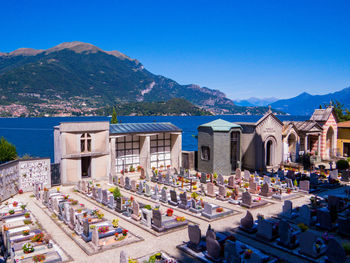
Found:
[0,115,310,161]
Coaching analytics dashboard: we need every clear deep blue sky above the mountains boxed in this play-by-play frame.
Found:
[0,0,350,99]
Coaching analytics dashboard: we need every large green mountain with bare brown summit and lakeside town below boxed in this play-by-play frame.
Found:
[0,41,280,116]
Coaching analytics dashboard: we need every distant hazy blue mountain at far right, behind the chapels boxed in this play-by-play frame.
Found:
[271,87,350,115]
